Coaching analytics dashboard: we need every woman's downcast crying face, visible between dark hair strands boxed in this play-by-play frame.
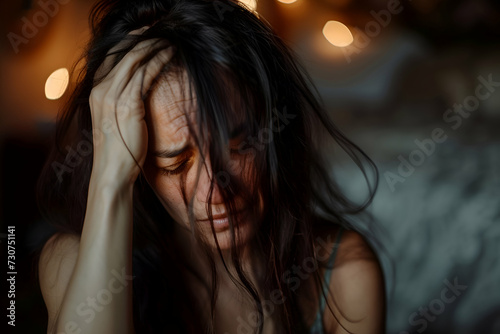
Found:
[144,72,262,249]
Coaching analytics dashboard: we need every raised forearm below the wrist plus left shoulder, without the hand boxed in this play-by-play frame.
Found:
[40,182,133,333]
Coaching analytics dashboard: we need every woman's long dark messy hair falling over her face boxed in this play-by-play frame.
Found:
[38,0,378,333]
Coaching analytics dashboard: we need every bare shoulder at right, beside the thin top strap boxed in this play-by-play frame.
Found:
[324,230,386,334]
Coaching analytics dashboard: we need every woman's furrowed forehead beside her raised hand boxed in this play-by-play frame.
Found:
[146,71,196,151]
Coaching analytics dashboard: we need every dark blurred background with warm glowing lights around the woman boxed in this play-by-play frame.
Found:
[0,0,500,334]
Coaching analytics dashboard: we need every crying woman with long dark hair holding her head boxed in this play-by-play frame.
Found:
[39,0,385,333]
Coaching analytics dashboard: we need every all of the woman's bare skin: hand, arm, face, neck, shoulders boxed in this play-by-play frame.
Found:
[39,29,385,334]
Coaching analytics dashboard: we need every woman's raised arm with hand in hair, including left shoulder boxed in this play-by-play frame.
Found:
[39,29,173,334]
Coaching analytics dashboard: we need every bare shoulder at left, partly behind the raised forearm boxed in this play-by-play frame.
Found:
[38,234,80,326]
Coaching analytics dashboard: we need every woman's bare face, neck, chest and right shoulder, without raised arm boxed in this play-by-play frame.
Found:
[135,53,385,334]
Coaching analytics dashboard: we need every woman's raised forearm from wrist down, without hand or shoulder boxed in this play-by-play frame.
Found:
[57,177,133,334]
